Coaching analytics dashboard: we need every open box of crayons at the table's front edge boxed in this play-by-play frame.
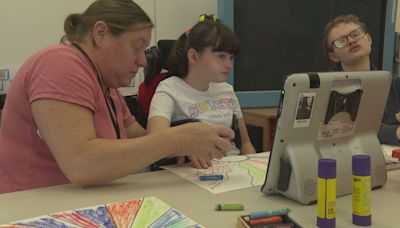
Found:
[237,208,302,228]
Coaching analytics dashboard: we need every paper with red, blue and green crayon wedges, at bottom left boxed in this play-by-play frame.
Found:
[0,197,203,228]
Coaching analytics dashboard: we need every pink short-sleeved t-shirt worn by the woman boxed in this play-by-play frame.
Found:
[0,45,135,193]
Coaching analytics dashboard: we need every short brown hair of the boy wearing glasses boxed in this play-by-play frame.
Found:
[323,14,368,54]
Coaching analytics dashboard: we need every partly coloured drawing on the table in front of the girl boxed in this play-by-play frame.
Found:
[162,152,269,193]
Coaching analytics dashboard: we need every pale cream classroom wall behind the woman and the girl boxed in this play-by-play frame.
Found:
[0,0,217,95]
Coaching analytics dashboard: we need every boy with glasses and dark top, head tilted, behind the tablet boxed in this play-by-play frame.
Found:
[323,14,400,146]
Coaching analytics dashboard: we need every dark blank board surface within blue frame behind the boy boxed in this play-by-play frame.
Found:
[234,0,387,91]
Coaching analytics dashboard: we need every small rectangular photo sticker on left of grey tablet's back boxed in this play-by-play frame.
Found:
[293,93,315,128]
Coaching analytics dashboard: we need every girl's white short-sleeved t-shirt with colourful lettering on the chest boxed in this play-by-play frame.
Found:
[149,76,243,127]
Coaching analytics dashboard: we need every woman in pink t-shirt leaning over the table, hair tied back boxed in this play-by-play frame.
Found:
[0,0,233,193]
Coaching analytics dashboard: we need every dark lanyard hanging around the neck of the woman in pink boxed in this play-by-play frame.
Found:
[72,43,121,139]
